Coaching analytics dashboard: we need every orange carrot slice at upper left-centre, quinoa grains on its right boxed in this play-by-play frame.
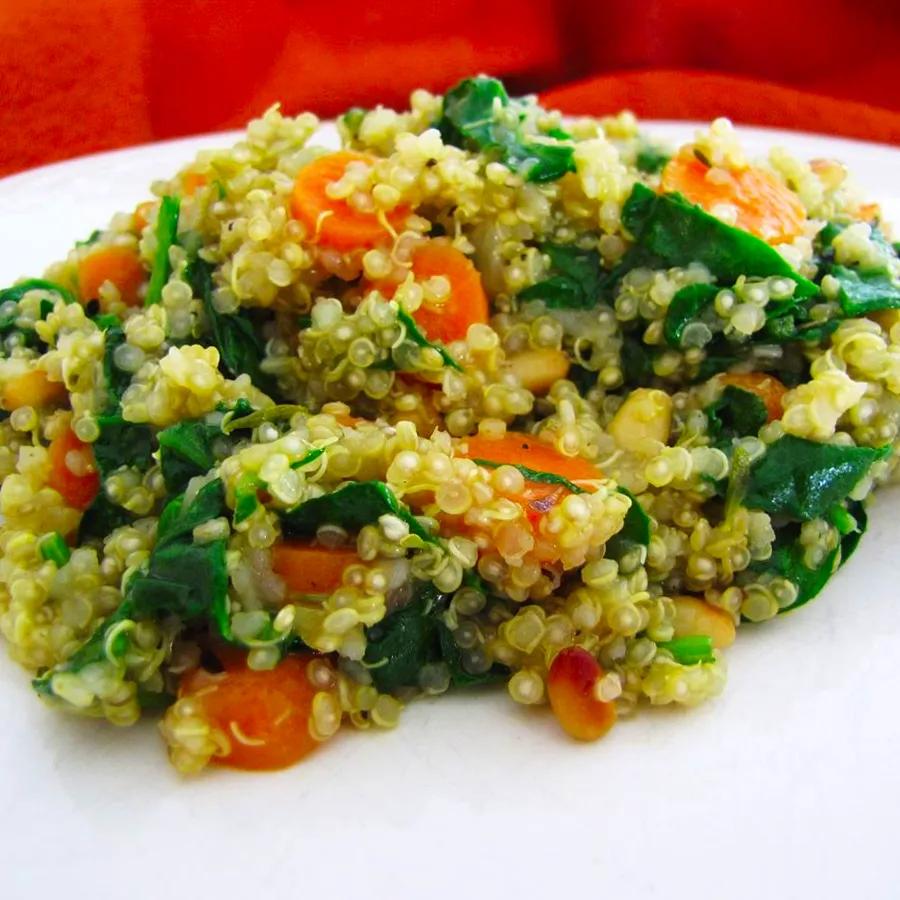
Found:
[291,150,409,251]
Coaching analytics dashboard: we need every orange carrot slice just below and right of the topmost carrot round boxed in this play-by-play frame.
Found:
[412,239,488,344]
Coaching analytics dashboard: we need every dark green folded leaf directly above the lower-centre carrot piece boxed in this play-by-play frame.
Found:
[281,481,435,542]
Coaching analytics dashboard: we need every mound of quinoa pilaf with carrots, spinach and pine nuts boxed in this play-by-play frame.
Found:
[0,76,900,773]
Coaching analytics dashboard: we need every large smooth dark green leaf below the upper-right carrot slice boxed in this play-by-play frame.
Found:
[622,184,819,299]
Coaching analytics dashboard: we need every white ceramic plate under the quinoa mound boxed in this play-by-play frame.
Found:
[0,123,900,900]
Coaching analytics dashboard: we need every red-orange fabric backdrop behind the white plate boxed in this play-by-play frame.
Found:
[0,0,900,174]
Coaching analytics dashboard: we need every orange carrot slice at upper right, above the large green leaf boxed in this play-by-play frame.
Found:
[661,151,806,244]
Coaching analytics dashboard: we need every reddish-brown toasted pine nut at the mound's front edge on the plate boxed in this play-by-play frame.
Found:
[547,647,616,741]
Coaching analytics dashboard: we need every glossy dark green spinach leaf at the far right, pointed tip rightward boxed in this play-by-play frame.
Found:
[743,435,891,522]
